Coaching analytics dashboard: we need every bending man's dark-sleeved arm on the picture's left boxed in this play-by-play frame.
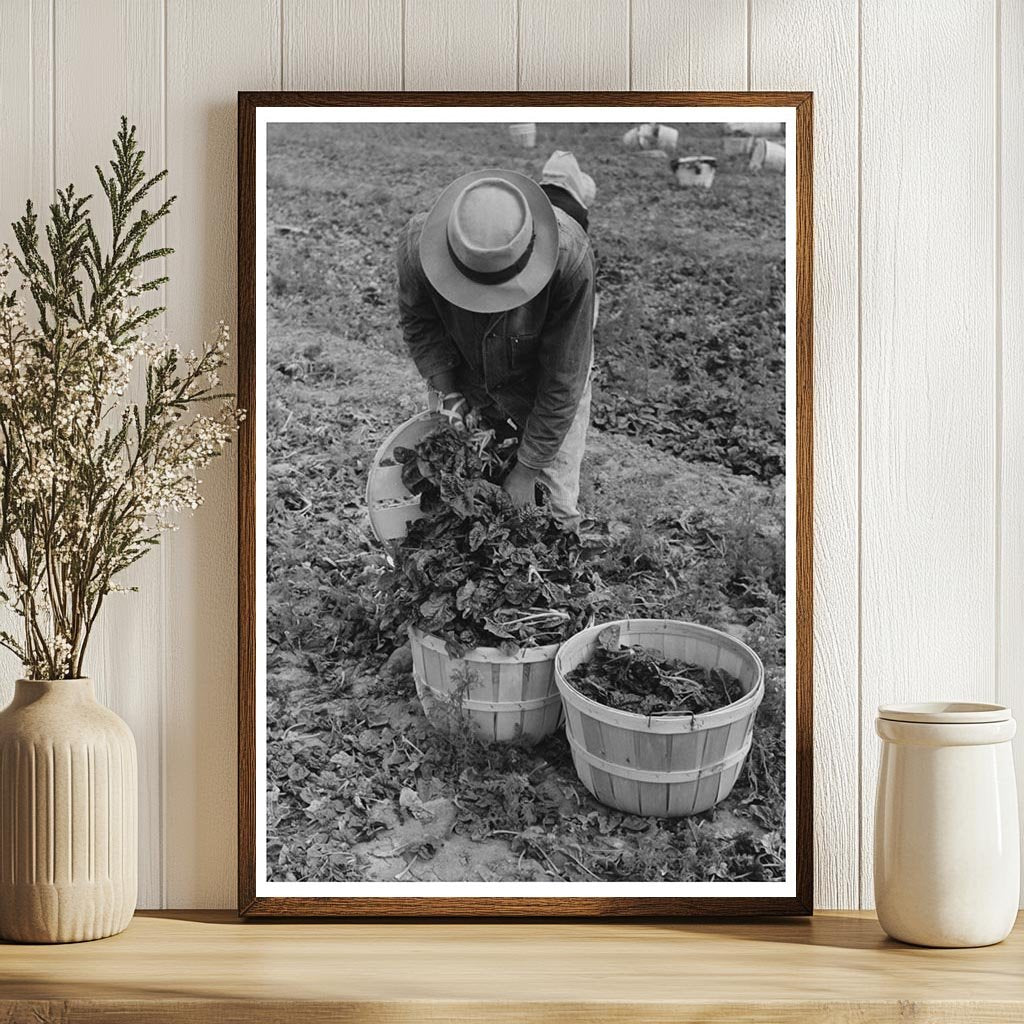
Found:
[398,215,461,394]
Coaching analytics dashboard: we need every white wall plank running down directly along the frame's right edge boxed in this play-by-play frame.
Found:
[750,0,860,907]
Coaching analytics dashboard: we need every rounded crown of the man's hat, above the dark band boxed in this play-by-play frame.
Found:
[447,177,534,273]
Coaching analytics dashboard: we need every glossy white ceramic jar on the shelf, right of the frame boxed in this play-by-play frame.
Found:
[874,703,1020,947]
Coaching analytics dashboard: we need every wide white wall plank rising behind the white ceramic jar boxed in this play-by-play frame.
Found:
[859,0,995,902]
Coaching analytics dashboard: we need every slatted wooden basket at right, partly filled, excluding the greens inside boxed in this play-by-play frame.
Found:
[555,618,764,817]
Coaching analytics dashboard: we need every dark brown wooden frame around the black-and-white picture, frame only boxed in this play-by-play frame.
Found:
[238,92,813,919]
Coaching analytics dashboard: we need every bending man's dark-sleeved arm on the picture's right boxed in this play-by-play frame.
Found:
[518,232,594,475]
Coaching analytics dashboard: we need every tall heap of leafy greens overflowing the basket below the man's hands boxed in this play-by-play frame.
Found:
[380,425,607,657]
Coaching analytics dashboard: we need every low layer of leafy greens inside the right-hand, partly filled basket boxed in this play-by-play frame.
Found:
[568,626,742,716]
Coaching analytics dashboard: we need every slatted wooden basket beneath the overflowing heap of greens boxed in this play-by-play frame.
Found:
[409,629,562,743]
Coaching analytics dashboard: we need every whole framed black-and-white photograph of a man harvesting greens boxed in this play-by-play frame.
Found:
[239,92,813,916]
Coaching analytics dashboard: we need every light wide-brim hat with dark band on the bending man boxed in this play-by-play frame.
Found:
[420,169,558,313]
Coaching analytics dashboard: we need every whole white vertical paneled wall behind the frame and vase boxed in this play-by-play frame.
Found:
[0,0,1024,907]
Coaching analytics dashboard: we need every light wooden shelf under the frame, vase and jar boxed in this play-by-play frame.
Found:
[0,911,1024,1024]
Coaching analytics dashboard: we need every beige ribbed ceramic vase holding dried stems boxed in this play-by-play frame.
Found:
[0,679,138,942]
